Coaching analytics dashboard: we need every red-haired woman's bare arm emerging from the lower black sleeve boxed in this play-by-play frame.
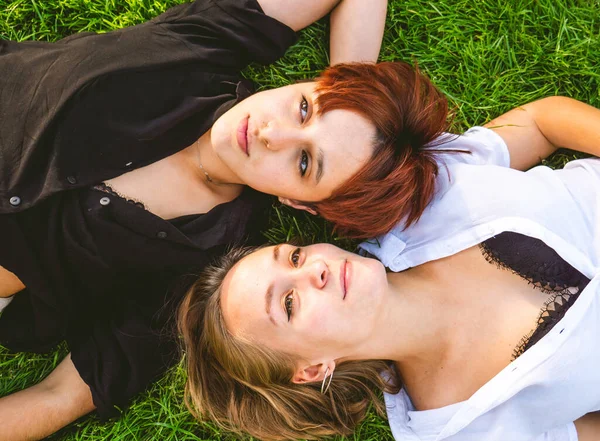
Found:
[0,355,95,441]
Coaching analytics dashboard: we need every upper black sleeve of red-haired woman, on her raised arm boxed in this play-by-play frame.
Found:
[157,0,296,70]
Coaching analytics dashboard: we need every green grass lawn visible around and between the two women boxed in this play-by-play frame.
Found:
[0,0,600,441]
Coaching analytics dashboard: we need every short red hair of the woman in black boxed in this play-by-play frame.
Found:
[301,62,462,238]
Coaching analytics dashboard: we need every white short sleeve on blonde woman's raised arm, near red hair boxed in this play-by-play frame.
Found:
[433,126,510,167]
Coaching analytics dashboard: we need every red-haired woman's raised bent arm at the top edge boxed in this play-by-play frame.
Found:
[258,0,387,64]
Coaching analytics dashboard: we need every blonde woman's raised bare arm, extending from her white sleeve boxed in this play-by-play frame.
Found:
[485,96,600,170]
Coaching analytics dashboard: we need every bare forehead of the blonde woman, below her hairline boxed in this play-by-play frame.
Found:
[221,247,274,335]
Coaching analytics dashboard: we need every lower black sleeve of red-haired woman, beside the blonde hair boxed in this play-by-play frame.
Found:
[67,276,180,420]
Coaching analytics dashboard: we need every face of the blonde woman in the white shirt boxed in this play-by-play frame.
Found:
[221,244,388,363]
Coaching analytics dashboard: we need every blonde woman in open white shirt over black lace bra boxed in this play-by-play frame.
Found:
[179,98,600,441]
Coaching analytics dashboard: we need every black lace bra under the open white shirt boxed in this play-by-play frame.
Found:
[479,232,590,360]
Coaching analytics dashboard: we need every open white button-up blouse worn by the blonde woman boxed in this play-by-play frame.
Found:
[361,128,600,441]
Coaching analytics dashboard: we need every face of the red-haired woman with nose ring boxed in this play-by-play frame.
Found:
[211,82,375,202]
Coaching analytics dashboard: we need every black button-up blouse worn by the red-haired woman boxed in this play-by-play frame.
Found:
[0,0,295,418]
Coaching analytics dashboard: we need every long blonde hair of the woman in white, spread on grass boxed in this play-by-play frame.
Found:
[178,248,399,440]
